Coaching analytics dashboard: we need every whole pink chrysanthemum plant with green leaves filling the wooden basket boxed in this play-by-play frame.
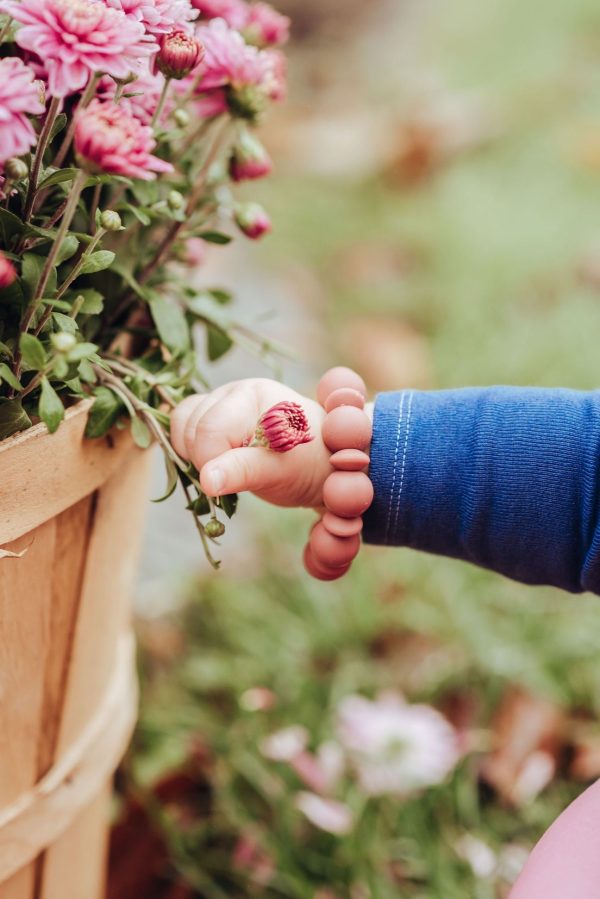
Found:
[0,0,289,568]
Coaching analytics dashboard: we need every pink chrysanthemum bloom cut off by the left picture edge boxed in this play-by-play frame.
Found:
[0,57,44,165]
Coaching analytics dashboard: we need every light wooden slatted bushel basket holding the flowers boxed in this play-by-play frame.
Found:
[0,402,148,899]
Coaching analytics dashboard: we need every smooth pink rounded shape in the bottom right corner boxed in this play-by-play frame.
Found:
[509,781,600,899]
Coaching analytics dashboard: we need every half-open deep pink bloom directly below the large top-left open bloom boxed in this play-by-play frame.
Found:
[74,100,173,181]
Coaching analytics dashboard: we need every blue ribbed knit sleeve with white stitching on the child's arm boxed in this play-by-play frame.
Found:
[364,387,600,593]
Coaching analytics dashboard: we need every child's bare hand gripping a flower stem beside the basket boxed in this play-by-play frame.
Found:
[171,378,332,508]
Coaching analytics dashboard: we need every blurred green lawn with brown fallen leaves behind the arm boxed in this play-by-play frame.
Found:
[110,0,600,899]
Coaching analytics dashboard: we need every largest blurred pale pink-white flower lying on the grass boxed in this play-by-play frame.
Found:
[337,693,459,796]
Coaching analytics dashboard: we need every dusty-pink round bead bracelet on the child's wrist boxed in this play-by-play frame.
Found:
[304,367,373,581]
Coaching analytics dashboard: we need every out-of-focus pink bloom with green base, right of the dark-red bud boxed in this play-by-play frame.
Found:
[197,19,285,121]
